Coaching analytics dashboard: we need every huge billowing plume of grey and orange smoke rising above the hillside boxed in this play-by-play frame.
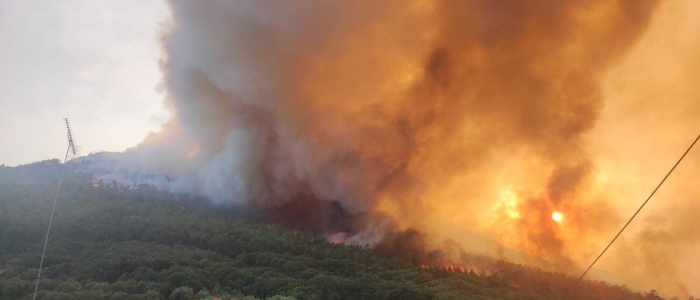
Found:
[108,0,697,296]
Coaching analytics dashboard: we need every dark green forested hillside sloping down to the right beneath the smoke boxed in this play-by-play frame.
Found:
[0,160,688,300]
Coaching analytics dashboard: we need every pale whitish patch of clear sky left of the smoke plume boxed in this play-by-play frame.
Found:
[0,0,168,165]
